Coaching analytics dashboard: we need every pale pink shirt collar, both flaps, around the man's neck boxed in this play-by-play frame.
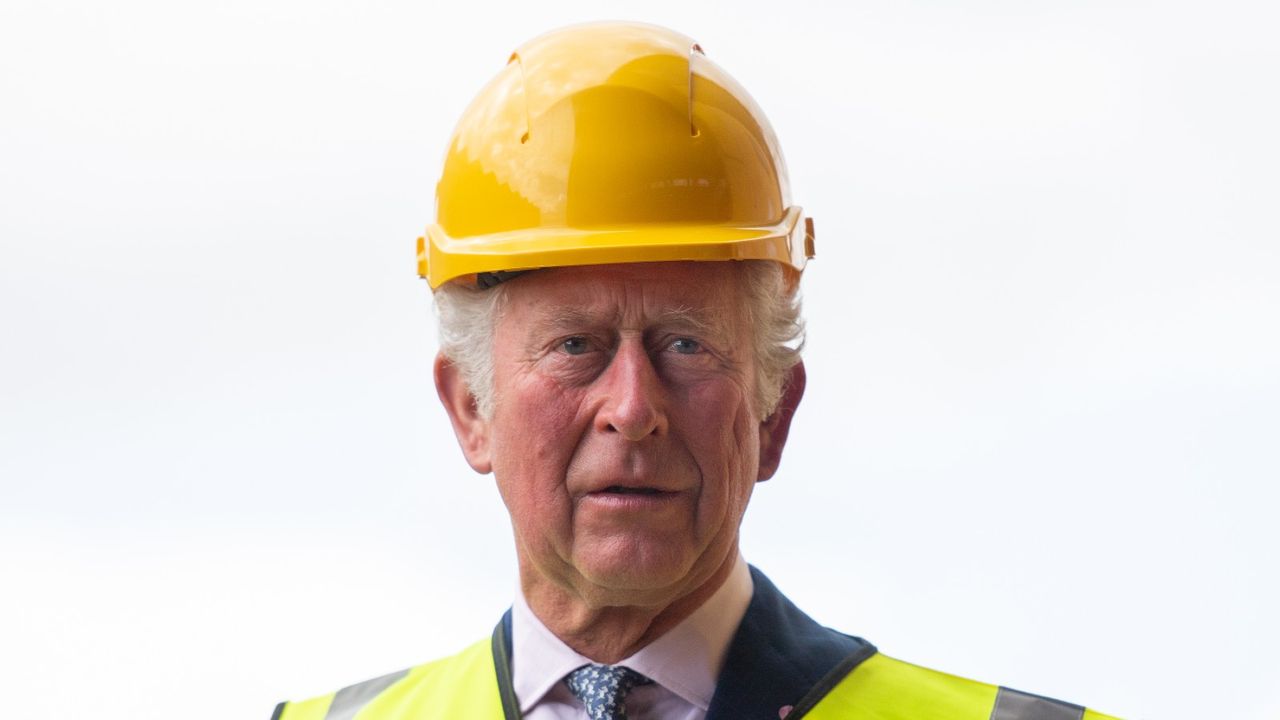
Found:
[511,556,754,714]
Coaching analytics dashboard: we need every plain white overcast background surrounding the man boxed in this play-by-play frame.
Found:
[0,0,1280,720]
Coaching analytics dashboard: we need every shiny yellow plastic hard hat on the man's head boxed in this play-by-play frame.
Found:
[417,23,813,290]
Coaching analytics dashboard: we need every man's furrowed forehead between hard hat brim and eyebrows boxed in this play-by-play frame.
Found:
[494,263,744,322]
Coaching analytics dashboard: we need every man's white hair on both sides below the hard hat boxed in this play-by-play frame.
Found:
[435,260,804,418]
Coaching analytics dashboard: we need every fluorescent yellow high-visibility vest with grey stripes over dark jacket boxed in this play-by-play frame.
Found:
[271,641,1116,720]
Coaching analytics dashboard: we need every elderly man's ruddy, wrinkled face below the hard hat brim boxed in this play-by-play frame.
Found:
[442,263,786,606]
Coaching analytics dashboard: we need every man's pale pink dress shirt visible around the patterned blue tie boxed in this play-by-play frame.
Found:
[511,556,754,720]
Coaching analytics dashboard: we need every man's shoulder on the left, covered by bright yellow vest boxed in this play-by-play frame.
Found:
[271,639,502,720]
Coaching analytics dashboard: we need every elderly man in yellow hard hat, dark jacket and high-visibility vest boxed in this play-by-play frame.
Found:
[275,23,1121,720]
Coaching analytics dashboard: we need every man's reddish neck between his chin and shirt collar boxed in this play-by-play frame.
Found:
[520,547,737,665]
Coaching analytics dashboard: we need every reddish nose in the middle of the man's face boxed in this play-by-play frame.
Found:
[595,340,667,442]
